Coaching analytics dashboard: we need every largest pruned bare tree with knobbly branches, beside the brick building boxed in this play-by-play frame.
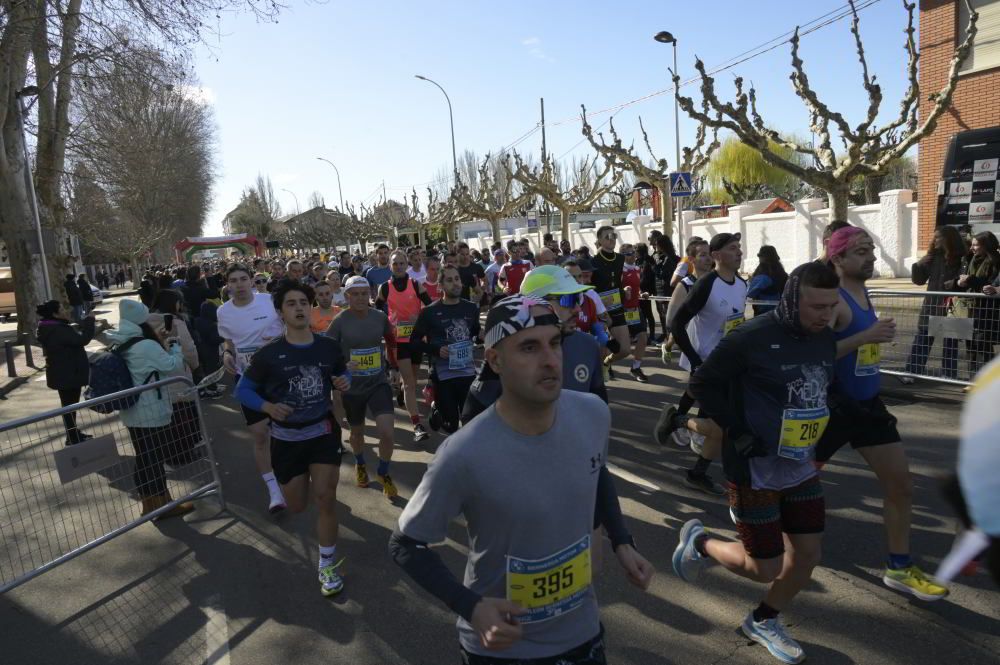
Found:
[674,0,978,220]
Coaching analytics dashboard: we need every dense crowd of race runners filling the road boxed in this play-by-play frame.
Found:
[48,222,1000,665]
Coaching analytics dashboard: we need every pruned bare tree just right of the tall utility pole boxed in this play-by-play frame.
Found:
[506,152,622,238]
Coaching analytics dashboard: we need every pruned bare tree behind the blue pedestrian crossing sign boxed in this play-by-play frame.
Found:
[580,105,719,235]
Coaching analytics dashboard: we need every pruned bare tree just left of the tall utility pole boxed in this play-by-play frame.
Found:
[451,155,534,240]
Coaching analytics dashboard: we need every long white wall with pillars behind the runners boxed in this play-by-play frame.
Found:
[468,189,920,277]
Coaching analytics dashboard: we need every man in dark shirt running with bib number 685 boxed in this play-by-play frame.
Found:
[410,266,481,434]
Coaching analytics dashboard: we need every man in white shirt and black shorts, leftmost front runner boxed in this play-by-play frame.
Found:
[216,263,286,513]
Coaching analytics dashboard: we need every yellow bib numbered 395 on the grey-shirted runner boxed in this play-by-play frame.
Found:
[507,535,592,623]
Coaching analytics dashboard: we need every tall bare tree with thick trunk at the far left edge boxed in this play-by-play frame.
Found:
[0,0,280,335]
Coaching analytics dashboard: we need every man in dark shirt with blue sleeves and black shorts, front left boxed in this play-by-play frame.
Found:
[237,281,350,596]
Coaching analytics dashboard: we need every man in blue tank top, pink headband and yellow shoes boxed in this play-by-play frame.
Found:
[816,226,948,601]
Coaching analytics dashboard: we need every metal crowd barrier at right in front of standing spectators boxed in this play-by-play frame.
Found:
[650,290,1000,385]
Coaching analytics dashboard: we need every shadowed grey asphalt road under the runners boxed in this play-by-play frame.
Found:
[0,296,1000,665]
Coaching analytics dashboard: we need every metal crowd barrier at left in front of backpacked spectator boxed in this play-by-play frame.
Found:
[0,377,224,593]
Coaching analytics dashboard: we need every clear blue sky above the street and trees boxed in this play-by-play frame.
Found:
[196,0,916,234]
